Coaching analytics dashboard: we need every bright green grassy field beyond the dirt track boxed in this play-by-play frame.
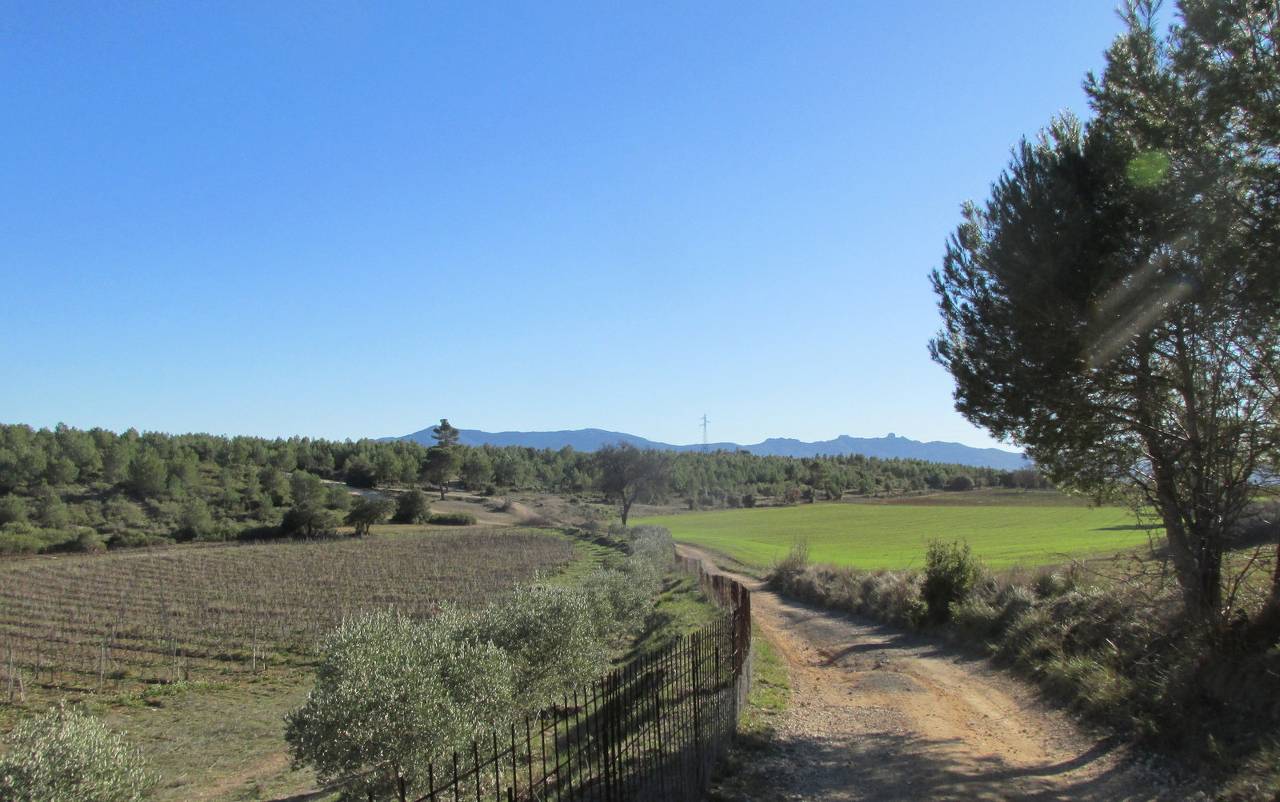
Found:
[636,492,1161,569]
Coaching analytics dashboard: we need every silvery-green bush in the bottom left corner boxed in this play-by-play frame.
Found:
[0,705,156,802]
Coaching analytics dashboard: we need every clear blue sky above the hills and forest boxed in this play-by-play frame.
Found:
[0,0,1120,445]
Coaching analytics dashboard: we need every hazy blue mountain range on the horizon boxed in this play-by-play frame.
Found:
[389,427,1030,471]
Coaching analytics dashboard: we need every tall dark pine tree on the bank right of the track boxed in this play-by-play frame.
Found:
[931,0,1280,620]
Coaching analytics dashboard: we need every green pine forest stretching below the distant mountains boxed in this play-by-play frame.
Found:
[0,421,1043,553]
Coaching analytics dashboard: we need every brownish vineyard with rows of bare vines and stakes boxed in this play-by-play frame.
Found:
[0,530,575,701]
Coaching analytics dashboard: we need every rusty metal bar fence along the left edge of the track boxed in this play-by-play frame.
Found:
[401,560,751,802]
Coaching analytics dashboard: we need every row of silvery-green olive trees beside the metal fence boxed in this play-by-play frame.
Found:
[285,527,675,799]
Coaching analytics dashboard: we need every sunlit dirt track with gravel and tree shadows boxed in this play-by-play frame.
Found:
[678,545,1180,801]
